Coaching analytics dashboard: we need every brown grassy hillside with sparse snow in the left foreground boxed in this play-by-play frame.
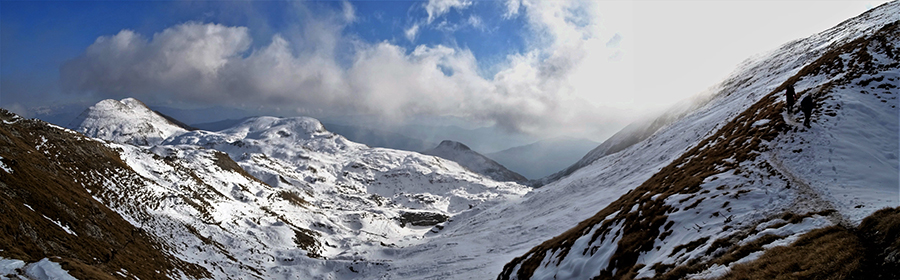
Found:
[0,109,209,279]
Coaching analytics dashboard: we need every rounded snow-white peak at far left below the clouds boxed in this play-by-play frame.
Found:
[74,98,187,145]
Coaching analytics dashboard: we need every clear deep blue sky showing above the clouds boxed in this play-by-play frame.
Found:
[0,1,525,99]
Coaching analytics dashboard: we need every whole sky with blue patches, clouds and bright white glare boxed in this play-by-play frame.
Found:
[0,0,886,141]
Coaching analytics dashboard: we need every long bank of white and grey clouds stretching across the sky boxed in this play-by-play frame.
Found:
[60,0,637,139]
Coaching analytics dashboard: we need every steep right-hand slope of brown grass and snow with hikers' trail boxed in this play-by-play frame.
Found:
[499,1,900,279]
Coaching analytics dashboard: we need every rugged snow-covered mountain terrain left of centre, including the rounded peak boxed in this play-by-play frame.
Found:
[67,99,529,279]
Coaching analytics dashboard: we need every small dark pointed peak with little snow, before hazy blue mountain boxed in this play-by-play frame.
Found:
[422,140,528,183]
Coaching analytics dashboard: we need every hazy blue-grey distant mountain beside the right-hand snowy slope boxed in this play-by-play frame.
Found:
[486,137,597,179]
